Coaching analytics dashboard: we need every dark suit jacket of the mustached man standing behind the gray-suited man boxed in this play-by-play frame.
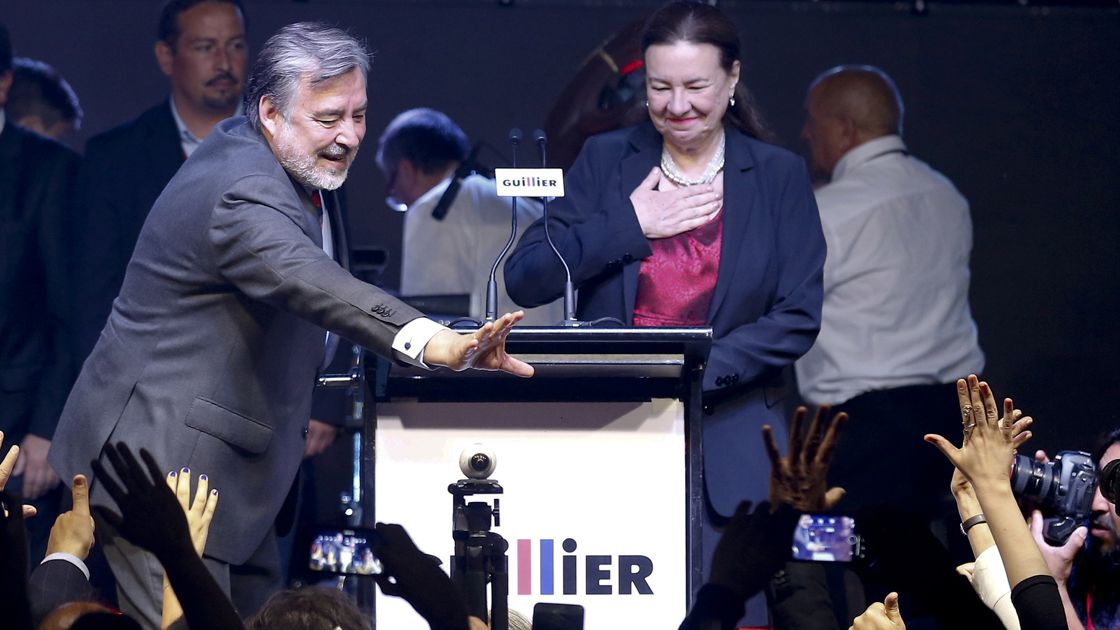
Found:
[71,101,185,361]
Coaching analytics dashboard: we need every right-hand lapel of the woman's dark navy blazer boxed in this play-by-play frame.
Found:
[708,128,757,323]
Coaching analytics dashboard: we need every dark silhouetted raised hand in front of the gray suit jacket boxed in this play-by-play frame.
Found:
[90,442,194,558]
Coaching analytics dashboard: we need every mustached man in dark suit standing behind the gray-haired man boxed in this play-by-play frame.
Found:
[71,0,249,364]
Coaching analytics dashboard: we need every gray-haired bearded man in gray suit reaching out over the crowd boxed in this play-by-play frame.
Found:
[50,24,532,626]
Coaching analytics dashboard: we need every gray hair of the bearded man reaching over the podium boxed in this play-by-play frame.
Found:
[244,22,370,131]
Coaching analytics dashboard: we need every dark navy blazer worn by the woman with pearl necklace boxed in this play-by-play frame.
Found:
[505,122,824,515]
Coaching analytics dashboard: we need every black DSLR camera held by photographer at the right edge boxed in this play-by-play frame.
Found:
[1011,451,1098,546]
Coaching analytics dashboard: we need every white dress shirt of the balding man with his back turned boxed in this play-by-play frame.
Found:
[795,136,984,405]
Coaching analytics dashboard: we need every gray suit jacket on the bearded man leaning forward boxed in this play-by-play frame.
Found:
[49,118,421,564]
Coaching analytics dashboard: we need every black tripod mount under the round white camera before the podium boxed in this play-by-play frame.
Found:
[447,479,510,630]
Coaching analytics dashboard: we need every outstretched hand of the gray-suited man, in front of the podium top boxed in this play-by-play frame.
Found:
[423,311,533,377]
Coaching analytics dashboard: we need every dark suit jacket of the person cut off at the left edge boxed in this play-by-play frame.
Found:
[0,120,78,444]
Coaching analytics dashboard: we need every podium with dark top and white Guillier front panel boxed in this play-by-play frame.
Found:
[370,327,711,630]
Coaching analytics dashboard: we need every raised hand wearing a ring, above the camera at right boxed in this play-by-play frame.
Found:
[925,374,1034,487]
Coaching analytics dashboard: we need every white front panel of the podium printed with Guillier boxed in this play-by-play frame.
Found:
[374,395,688,630]
